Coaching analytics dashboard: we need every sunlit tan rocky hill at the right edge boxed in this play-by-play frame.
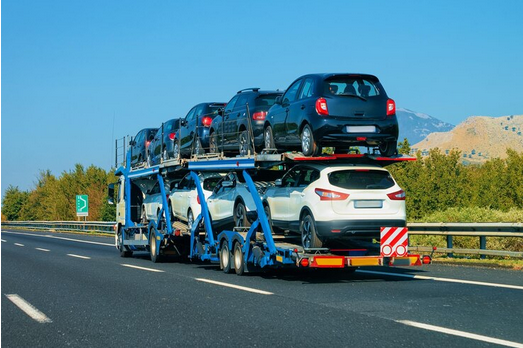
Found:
[411,115,523,163]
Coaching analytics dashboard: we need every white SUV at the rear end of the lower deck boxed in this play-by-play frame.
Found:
[263,164,406,248]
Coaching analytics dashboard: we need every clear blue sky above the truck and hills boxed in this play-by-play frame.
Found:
[1,0,523,196]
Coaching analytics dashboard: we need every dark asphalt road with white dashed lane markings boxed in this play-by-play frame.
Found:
[0,230,523,347]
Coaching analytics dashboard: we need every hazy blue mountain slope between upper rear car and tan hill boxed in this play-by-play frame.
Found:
[396,108,454,145]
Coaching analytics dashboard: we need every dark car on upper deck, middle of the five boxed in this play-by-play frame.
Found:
[174,103,225,157]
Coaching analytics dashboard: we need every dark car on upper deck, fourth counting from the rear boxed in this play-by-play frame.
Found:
[147,118,180,165]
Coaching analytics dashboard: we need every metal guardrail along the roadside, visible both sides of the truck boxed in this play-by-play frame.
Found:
[2,221,523,258]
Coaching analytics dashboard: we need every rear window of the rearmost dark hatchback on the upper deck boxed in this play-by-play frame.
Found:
[323,75,380,98]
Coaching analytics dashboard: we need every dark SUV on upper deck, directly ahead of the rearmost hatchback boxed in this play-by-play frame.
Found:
[210,88,283,156]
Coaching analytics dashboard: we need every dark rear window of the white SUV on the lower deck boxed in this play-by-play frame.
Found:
[329,169,394,190]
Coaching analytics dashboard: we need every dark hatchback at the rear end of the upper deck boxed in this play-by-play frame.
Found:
[263,74,398,157]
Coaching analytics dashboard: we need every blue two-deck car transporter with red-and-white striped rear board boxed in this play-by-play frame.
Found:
[109,147,431,275]
